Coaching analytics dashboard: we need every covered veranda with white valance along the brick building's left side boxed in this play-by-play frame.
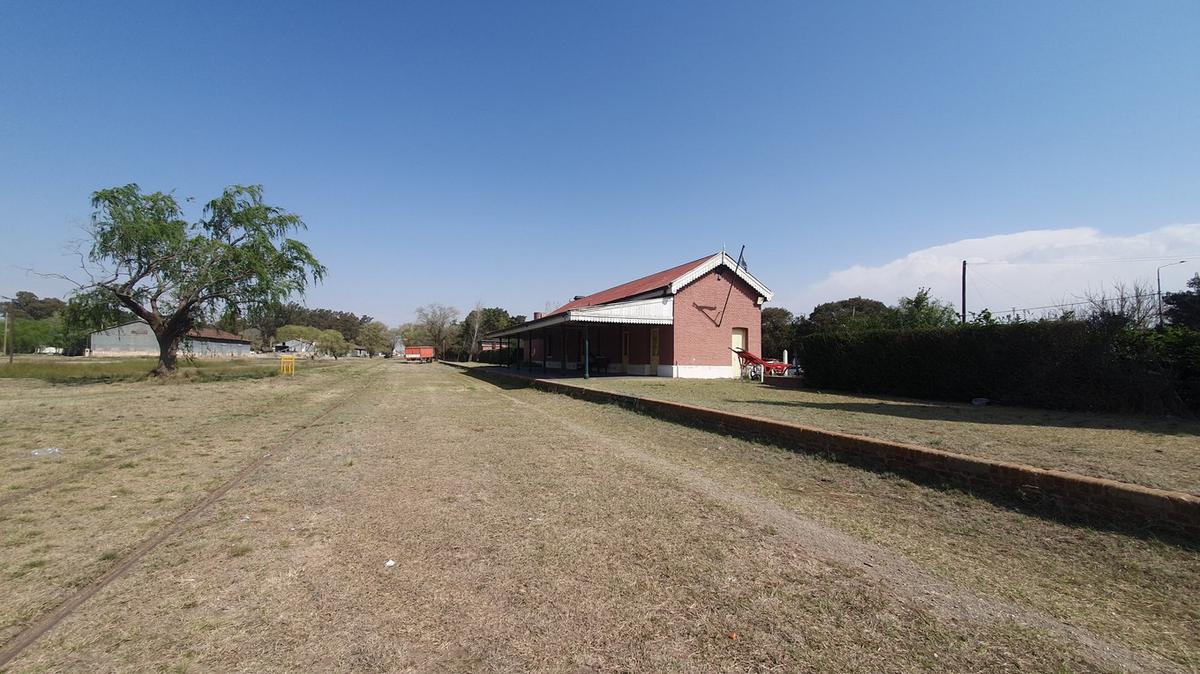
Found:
[486,297,673,378]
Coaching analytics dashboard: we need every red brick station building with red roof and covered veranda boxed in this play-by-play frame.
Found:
[487,252,772,379]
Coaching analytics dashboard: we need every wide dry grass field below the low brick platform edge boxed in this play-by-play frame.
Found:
[0,361,1200,673]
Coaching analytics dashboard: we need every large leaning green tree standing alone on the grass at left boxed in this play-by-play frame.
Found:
[70,183,325,375]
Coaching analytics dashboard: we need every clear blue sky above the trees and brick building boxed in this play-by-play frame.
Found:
[0,1,1200,324]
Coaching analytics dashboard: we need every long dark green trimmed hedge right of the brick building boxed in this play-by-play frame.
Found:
[799,321,1200,414]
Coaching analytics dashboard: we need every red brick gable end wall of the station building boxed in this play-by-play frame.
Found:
[662,267,762,365]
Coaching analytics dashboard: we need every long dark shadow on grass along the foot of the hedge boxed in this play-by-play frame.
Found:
[725,398,1200,435]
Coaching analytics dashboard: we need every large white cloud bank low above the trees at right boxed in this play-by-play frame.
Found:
[796,224,1200,313]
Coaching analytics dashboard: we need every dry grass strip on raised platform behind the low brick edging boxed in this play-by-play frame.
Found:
[571,377,1200,494]
